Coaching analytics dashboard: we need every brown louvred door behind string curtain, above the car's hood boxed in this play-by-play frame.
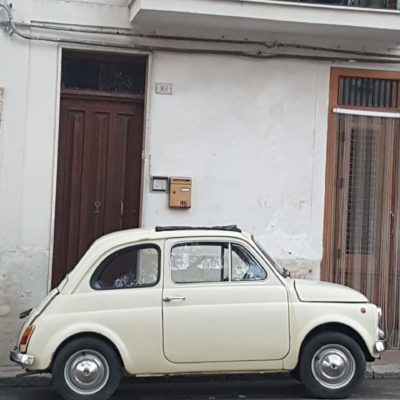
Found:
[332,115,400,346]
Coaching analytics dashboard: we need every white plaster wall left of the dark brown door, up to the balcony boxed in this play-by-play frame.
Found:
[0,0,129,368]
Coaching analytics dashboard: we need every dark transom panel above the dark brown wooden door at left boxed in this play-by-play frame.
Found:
[61,58,145,94]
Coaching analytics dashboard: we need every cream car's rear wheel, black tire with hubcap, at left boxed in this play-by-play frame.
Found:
[52,337,122,400]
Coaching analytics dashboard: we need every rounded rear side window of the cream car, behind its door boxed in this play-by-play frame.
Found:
[90,245,160,290]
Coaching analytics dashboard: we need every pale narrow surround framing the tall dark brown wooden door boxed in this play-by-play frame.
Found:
[47,45,153,292]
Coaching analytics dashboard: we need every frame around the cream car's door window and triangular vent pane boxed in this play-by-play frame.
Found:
[170,237,271,286]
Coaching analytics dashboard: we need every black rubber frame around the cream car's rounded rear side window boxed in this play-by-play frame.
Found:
[89,243,162,291]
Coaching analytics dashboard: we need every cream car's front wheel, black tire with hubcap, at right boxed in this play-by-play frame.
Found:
[298,331,366,399]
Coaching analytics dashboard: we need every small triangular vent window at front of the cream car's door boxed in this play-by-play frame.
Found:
[232,244,267,281]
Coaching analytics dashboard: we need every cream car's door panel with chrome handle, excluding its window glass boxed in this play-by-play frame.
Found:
[163,241,289,363]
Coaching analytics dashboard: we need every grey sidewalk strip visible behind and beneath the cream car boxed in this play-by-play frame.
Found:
[0,350,400,387]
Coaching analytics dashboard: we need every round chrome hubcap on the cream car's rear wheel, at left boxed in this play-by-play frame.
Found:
[64,350,110,395]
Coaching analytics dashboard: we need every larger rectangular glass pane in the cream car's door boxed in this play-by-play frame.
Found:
[171,242,229,283]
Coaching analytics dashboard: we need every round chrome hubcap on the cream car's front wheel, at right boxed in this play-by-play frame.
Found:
[311,344,356,389]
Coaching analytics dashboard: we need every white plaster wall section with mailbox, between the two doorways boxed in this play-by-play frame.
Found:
[143,53,329,278]
